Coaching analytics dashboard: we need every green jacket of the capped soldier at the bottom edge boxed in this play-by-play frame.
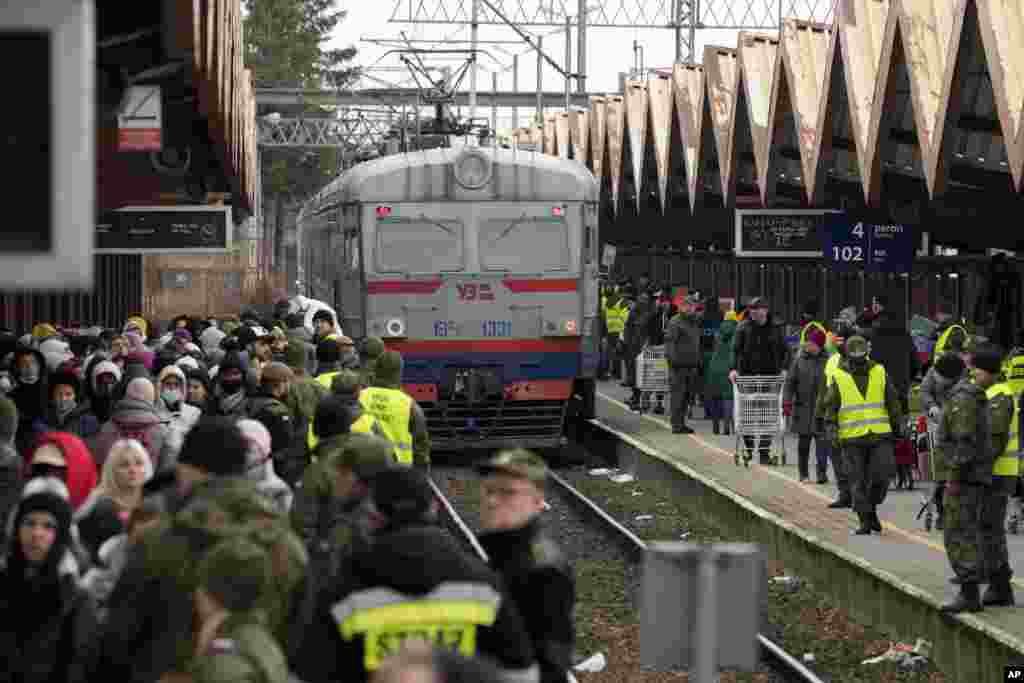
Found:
[190,611,288,683]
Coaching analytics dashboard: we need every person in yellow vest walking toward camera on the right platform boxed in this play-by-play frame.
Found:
[821,336,903,536]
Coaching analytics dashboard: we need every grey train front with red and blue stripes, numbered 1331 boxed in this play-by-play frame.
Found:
[342,148,599,451]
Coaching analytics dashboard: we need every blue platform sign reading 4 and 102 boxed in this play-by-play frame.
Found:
[824,214,916,273]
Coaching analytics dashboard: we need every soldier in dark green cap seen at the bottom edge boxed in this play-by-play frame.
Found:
[189,538,288,683]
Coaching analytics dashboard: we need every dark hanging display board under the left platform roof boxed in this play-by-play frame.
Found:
[95,206,232,254]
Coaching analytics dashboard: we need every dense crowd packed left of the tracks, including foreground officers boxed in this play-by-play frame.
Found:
[0,309,574,683]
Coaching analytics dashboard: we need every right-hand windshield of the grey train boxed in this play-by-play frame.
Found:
[480,216,569,272]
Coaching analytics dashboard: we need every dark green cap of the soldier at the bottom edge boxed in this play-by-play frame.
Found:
[199,537,270,612]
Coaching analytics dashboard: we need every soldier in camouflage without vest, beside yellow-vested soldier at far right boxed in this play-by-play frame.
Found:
[938,350,993,613]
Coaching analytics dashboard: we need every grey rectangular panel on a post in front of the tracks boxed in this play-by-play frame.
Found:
[640,542,765,683]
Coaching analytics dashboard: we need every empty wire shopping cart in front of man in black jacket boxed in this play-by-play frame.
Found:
[732,375,785,467]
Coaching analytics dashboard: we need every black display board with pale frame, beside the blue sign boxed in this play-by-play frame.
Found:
[735,209,839,258]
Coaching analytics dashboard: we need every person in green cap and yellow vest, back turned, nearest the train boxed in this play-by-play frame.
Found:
[359,351,430,465]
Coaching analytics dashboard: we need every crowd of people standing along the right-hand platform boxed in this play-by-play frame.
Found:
[602,279,1024,612]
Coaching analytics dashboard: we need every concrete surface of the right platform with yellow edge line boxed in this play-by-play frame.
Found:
[597,381,1024,637]
